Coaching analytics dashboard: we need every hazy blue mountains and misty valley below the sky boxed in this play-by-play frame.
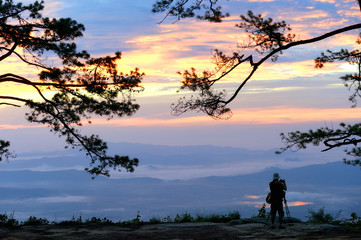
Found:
[0,143,361,221]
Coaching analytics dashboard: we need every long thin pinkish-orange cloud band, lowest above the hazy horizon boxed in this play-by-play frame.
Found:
[84,106,361,127]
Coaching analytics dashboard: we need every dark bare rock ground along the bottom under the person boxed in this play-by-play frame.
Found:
[0,223,361,240]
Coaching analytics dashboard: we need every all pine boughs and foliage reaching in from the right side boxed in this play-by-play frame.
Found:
[157,1,361,165]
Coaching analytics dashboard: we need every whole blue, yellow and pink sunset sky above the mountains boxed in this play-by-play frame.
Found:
[0,0,361,152]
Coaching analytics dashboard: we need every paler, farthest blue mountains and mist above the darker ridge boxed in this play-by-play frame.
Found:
[0,143,343,180]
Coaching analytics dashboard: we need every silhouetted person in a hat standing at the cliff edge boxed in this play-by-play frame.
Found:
[269,173,287,229]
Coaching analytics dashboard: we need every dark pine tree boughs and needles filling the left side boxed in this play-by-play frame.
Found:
[0,0,144,176]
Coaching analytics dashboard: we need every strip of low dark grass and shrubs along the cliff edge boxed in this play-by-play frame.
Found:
[0,205,361,232]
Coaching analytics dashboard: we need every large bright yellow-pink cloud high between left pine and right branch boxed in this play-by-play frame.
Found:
[121,17,247,81]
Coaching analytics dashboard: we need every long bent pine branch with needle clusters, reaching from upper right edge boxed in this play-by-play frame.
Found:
[172,11,361,118]
